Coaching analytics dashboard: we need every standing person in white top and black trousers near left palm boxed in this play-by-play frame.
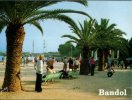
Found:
[35,56,43,92]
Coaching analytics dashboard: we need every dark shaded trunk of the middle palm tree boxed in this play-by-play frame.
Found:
[80,47,90,75]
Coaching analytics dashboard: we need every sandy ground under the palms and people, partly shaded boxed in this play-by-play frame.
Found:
[0,63,132,100]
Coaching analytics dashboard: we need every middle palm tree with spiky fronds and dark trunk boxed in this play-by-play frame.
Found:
[62,20,96,75]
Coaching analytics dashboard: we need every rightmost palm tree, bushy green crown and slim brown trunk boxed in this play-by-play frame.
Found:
[95,19,125,71]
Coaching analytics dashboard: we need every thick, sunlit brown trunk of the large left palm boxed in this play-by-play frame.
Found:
[2,24,25,92]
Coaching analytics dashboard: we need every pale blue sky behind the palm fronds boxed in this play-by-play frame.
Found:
[0,1,132,53]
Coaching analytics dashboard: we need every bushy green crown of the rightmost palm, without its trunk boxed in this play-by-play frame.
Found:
[94,19,128,52]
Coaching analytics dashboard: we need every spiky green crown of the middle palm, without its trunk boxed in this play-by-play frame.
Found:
[62,20,95,48]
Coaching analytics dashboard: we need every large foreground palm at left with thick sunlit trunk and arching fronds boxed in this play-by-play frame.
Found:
[0,0,89,91]
